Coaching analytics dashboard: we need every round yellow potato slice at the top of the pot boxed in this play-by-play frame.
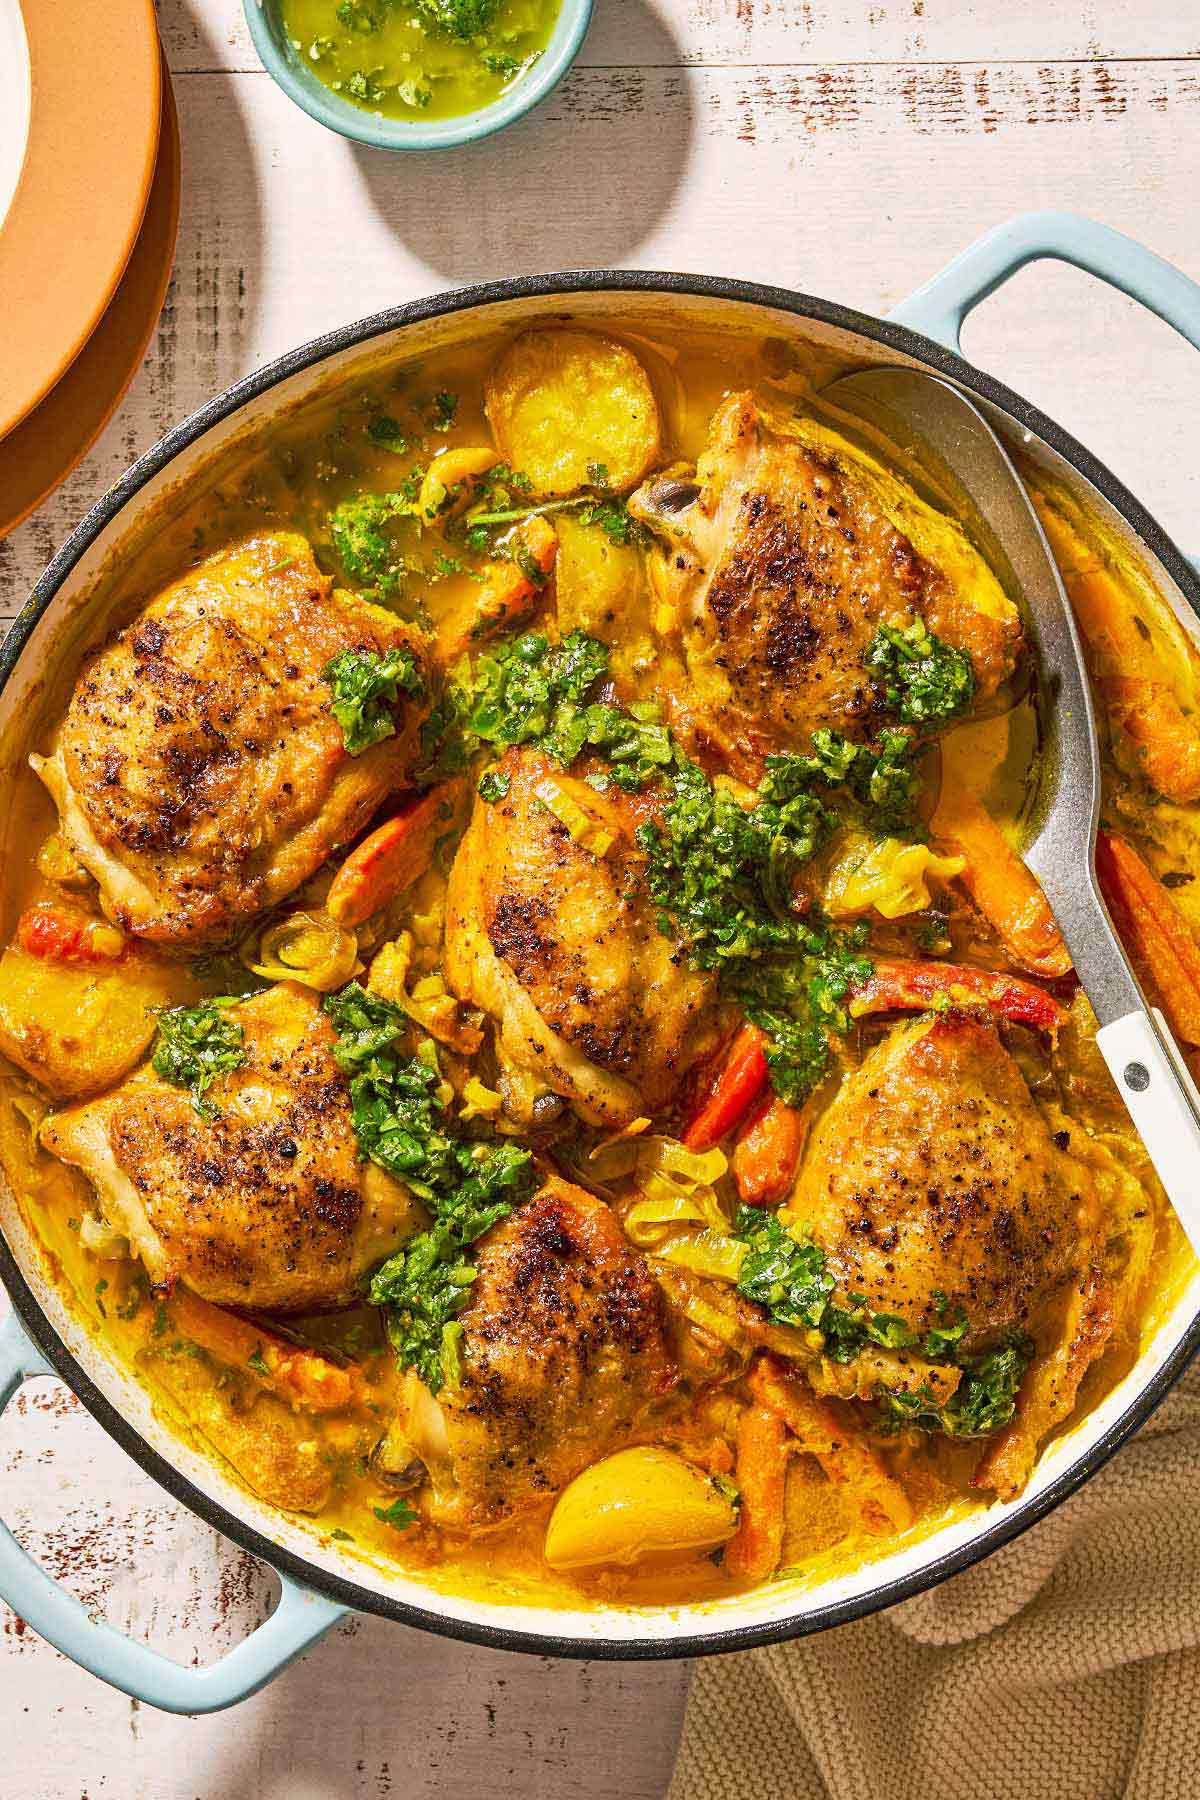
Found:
[486,331,660,495]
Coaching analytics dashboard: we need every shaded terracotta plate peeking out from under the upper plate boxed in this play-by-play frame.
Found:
[0,70,180,538]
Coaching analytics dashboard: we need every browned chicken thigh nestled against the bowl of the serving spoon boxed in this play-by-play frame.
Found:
[630,394,1020,765]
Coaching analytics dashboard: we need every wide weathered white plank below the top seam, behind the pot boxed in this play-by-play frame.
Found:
[0,51,1200,617]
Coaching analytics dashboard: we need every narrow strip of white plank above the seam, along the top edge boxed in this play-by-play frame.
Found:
[158,0,1200,70]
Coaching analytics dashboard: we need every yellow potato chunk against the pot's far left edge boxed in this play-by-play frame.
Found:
[0,945,178,1100]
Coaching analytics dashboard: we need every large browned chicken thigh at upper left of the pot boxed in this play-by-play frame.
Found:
[32,531,425,943]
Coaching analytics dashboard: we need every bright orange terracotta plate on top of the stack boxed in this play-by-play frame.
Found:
[0,0,162,439]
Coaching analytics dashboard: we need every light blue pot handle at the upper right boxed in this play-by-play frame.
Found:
[887,212,1200,355]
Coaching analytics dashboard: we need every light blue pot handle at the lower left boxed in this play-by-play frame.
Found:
[0,1312,347,1714]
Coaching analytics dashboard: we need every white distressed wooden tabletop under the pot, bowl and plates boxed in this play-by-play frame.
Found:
[0,0,1200,1800]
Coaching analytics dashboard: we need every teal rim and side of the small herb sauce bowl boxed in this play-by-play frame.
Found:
[245,0,592,149]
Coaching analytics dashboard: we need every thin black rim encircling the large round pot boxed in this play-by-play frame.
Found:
[0,268,1200,1661]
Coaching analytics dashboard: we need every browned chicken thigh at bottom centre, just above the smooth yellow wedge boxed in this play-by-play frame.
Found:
[380,1179,676,1530]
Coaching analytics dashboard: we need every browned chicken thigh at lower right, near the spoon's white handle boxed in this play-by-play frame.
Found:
[788,1012,1097,1345]
